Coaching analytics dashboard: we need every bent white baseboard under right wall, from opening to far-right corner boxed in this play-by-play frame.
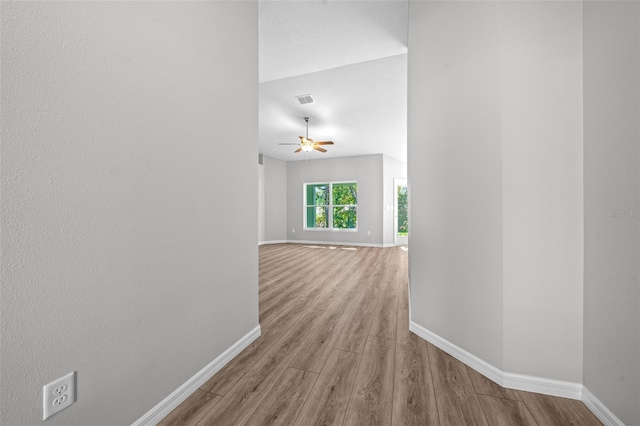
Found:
[409,321,583,400]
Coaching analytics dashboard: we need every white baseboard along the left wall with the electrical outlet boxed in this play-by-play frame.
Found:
[132,325,260,426]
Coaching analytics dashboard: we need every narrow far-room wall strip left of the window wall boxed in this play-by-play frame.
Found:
[263,155,287,241]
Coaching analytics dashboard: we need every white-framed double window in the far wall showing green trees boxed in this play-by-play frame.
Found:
[304,182,358,231]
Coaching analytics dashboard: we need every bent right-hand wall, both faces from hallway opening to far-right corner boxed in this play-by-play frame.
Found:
[408,2,582,383]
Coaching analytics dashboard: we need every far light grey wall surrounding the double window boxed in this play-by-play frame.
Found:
[287,154,383,245]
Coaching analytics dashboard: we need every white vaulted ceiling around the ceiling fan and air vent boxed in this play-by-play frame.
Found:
[259,0,408,161]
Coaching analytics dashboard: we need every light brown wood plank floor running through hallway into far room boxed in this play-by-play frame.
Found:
[160,244,601,426]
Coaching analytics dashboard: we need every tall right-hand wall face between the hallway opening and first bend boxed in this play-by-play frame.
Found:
[407,2,503,368]
